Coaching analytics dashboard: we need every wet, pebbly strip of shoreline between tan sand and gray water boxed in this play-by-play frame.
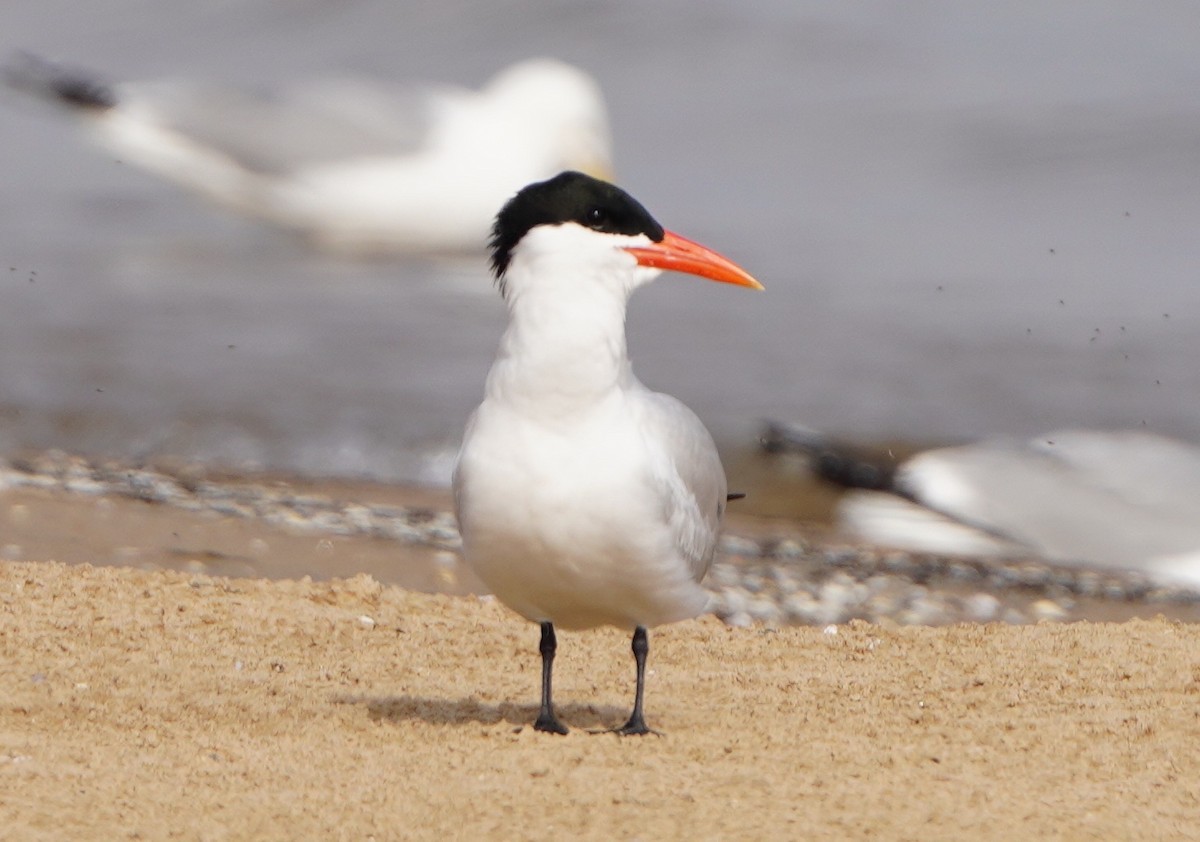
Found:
[0,453,1200,626]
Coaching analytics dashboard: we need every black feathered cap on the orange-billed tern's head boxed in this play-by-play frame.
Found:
[491,172,662,278]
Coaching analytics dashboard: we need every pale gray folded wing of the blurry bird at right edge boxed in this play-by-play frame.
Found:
[898,431,1200,566]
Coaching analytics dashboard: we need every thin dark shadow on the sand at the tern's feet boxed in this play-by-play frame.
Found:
[334,694,629,732]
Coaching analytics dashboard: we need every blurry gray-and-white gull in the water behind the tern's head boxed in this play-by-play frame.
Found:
[5,55,612,254]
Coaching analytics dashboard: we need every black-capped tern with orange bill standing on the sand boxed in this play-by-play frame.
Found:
[454,173,762,734]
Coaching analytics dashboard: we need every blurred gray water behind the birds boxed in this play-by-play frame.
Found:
[0,0,1200,482]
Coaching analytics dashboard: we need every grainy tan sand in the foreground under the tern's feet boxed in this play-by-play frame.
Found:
[0,546,1200,840]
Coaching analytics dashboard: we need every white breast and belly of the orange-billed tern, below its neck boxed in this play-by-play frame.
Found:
[456,404,708,629]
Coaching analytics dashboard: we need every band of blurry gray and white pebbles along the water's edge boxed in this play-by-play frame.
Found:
[0,451,1200,626]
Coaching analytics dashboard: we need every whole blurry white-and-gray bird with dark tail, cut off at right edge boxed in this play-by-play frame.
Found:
[764,425,1200,585]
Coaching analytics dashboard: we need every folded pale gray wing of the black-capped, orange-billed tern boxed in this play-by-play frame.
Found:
[641,392,726,582]
